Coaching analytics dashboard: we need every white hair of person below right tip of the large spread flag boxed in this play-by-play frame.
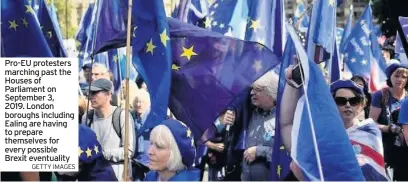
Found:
[253,71,279,101]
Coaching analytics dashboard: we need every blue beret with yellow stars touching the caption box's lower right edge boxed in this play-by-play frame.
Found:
[78,124,102,163]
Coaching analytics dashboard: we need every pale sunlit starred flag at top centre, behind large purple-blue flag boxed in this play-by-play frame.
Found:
[205,0,284,56]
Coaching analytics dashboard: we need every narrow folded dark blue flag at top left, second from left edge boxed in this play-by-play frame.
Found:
[38,0,67,57]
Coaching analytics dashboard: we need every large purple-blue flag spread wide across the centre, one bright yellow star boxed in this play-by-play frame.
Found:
[169,19,280,138]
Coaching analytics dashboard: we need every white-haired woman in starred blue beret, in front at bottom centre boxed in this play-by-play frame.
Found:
[145,119,200,181]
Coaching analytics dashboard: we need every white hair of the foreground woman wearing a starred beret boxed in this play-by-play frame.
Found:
[150,125,186,172]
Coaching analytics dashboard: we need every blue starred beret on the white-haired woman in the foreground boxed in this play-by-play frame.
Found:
[161,119,196,167]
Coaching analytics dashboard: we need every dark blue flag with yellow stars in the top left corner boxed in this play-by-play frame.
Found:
[1,0,53,57]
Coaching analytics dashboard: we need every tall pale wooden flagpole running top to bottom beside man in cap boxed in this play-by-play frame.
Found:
[123,0,132,181]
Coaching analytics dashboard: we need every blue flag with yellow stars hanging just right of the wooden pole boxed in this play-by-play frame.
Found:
[132,0,171,134]
